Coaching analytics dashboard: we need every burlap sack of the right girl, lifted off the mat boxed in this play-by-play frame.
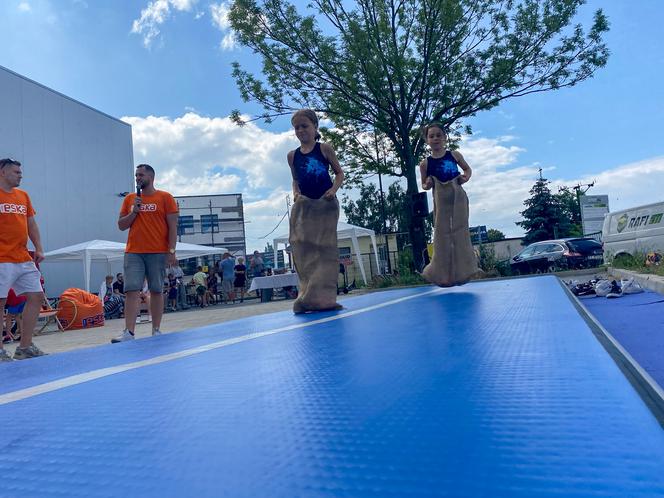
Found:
[422,177,478,287]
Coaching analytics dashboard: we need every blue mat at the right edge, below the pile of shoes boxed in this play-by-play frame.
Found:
[581,292,664,387]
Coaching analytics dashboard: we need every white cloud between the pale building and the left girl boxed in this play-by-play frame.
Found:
[122,112,297,250]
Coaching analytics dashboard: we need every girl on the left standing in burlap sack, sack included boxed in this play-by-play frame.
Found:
[288,109,344,313]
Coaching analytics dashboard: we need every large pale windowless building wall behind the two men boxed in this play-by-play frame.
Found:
[0,66,134,296]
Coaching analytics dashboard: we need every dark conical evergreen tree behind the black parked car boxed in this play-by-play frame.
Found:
[516,176,573,245]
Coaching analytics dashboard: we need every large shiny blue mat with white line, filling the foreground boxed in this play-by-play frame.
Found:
[0,276,664,498]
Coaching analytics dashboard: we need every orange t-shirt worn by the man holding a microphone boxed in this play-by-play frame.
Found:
[120,190,178,253]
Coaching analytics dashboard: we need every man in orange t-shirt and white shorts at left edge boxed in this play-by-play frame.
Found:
[0,159,45,361]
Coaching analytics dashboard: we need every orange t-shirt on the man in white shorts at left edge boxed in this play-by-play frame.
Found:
[0,188,35,263]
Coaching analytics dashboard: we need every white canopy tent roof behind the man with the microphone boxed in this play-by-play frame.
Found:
[44,240,227,292]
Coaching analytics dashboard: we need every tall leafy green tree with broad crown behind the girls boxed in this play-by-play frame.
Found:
[229,0,608,268]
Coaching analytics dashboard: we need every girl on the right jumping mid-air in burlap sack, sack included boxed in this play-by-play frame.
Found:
[420,123,478,287]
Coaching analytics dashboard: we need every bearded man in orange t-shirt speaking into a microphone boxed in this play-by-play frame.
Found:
[111,164,178,342]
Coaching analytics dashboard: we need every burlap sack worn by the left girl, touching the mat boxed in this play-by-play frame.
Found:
[288,195,341,313]
